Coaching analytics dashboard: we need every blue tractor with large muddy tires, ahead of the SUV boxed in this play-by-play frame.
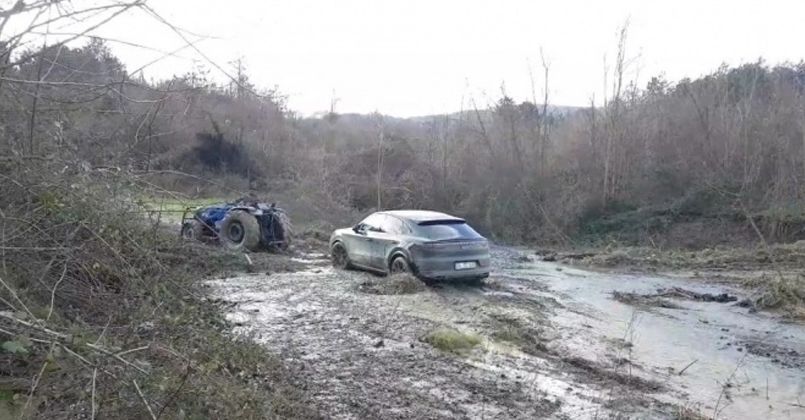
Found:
[181,198,291,251]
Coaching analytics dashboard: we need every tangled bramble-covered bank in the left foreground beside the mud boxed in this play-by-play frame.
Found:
[0,162,317,419]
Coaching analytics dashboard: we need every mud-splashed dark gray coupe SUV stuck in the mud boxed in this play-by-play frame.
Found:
[330,210,490,279]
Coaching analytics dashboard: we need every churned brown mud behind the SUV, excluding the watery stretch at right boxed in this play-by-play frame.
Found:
[204,248,804,419]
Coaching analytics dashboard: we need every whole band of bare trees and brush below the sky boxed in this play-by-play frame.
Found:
[0,40,805,245]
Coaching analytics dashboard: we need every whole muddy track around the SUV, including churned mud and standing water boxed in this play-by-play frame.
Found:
[208,248,805,419]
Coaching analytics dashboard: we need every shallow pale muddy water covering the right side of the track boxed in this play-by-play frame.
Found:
[506,262,805,419]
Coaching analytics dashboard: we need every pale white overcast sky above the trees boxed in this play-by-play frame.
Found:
[31,0,805,116]
